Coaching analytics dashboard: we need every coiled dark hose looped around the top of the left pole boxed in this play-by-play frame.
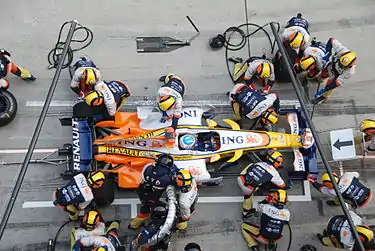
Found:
[48,21,94,69]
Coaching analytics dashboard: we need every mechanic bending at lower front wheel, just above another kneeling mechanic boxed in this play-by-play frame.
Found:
[237,152,291,218]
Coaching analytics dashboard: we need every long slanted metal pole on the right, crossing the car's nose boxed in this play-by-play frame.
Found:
[270,22,365,251]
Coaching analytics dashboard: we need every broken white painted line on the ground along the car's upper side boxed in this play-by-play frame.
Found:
[26,99,300,107]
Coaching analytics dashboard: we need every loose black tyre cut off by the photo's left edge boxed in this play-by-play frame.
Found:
[0,90,17,126]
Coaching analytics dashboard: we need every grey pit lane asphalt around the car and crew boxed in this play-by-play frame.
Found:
[0,0,375,250]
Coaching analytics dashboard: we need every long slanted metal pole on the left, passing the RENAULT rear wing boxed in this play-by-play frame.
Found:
[0,20,77,240]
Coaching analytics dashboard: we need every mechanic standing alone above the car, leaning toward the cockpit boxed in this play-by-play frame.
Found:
[157,73,185,130]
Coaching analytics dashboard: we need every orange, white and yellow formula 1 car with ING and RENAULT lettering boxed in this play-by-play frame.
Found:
[58,104,316,194]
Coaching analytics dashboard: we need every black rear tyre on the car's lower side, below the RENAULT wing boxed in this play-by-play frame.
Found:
[93,175,115,206]
